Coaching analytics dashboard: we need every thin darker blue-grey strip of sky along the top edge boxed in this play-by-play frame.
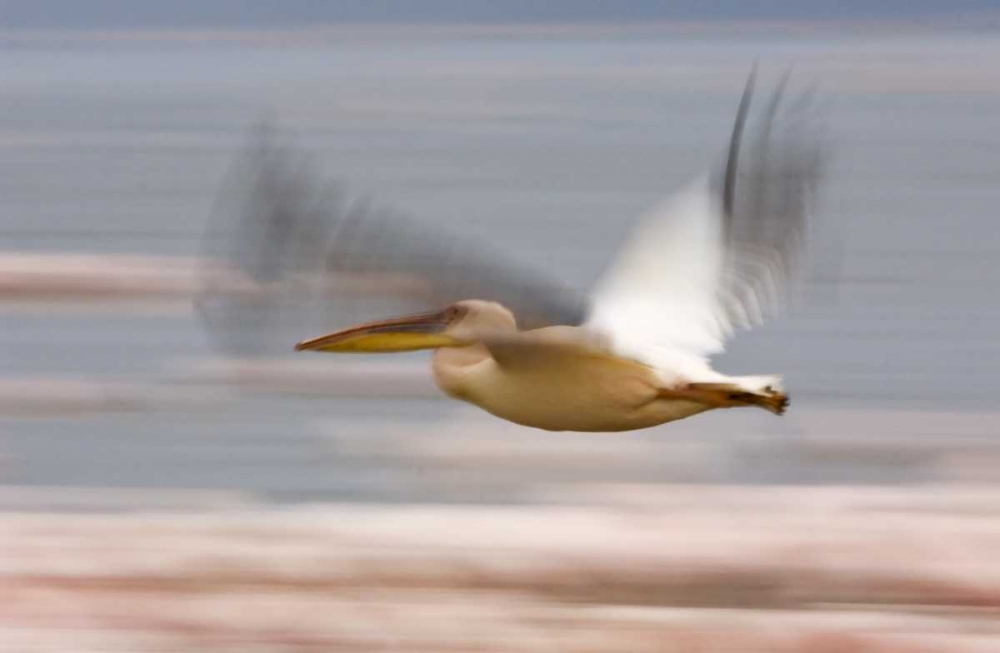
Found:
[0,0,1000,30]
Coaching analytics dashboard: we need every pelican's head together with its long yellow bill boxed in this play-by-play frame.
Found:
[295,299,517,354]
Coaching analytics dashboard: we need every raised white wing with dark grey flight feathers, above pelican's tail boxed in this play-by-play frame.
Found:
[588,75,820,364]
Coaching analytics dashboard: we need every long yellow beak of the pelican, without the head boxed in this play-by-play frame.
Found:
[295,311,461,354]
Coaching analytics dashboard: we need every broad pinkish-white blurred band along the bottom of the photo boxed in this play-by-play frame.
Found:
[0,487,1000,653]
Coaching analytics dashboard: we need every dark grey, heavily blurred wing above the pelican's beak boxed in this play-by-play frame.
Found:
[197,125,585,355]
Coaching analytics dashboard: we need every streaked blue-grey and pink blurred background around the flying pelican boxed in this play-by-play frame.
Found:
[0,0,1000,652]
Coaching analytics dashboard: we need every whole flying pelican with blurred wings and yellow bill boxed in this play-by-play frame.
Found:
[199,73,821,432]
